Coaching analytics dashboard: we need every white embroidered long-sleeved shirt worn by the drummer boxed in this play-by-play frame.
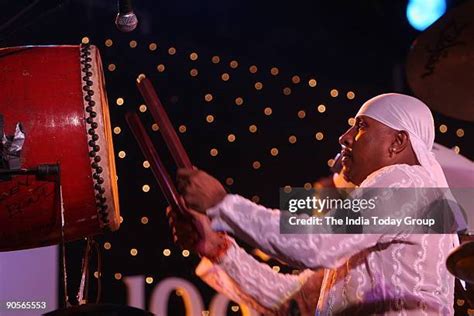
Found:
[207,165,457,315]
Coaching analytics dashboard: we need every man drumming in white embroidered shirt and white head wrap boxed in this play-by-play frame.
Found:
[173,93,458,315]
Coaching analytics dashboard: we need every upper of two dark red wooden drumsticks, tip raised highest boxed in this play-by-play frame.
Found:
[137,74,193,168]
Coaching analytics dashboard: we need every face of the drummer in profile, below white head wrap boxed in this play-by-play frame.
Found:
[339,115,396,185]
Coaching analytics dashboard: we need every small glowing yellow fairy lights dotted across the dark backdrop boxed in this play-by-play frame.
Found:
[78,37,465,315]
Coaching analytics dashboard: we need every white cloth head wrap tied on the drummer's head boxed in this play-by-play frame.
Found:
[356,93,448,188]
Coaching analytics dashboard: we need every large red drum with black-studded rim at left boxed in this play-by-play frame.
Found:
[0,46,120,251]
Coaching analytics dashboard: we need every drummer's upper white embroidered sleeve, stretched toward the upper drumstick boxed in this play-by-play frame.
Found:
[207,194,381,269]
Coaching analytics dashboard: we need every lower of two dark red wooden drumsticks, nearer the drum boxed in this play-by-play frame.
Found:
[125,112,189,216]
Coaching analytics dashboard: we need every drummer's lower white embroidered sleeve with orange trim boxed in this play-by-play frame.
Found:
[196,239,313,311]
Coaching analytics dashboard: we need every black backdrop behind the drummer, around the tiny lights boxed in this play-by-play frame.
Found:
[0,0,474,315]
